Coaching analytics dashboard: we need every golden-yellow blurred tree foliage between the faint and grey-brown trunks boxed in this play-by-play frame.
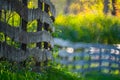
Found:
[69,0,103,14]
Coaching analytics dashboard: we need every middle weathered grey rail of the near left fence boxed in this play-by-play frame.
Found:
[0,22,53,47]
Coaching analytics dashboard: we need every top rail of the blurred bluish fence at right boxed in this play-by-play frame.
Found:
[54,38,120,51]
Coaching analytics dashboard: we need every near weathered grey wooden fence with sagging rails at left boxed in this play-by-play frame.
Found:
[0,0,55,65]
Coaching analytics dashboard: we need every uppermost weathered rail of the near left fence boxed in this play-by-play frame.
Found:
[0,0,53,27]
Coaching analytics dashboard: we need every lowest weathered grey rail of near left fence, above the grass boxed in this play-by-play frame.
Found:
[0,43,52,62]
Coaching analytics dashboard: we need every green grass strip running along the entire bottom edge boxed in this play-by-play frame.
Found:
[0,61,120,80]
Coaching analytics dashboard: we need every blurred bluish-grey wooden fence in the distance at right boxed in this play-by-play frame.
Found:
[54,38,120,73]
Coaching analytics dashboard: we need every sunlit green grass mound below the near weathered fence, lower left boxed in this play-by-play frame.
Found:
[0,61,78,80]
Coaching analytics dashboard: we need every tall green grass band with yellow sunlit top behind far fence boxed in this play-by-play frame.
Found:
[55,13,120,44]
